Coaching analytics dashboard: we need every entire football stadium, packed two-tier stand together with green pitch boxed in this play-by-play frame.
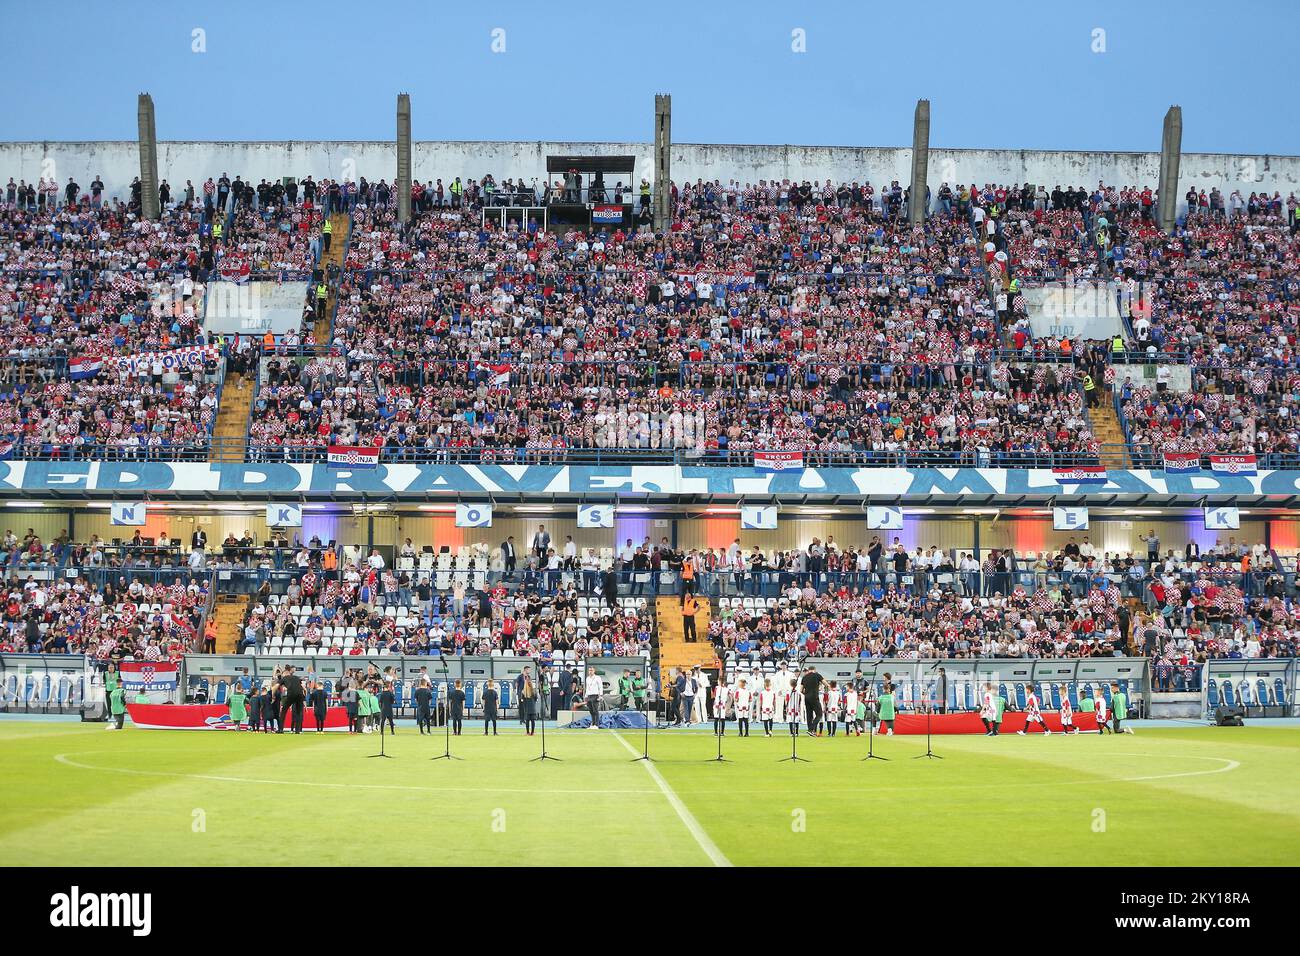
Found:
[0,5,1300,894]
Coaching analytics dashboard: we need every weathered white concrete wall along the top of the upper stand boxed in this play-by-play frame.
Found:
[0,140,1300,217]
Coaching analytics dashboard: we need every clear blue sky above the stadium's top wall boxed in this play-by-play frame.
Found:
[0,0,1300,153]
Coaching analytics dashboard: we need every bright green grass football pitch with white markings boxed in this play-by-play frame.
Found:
[0,721,1300,866]
